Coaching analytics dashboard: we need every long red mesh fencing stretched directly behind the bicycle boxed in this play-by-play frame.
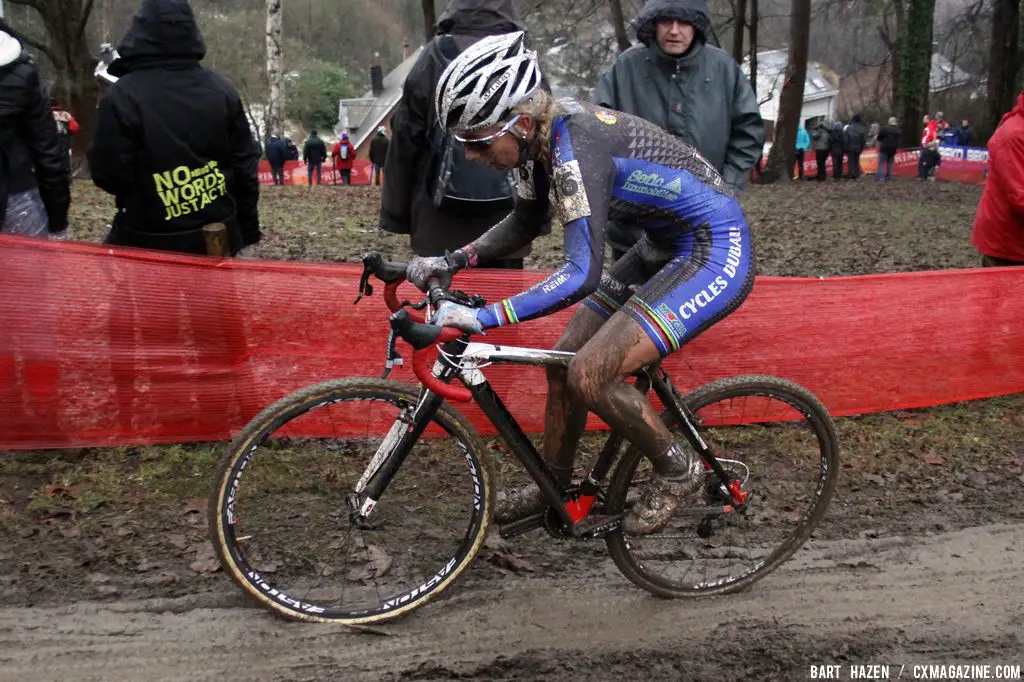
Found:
[0,237,1024,450]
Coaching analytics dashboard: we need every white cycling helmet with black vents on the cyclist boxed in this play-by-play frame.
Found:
[434,31,541,130]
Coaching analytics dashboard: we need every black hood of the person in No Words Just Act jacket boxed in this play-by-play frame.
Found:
[109,0,206,76]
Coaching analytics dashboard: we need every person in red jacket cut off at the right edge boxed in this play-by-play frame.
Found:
[971,92,1024,267]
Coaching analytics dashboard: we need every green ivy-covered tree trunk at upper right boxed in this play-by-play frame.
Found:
[896,0,935,146]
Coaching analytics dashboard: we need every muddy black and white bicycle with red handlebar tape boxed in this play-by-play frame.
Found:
[209,254,839,625]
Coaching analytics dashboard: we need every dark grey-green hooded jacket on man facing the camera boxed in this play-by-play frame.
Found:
[594,0,764,188]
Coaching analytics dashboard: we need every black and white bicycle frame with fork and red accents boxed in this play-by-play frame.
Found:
[360,339,748,537]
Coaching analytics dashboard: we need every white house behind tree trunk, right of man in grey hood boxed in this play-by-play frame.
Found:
[742,49,839,135]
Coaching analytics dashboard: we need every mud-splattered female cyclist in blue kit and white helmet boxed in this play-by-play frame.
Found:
[408,33,755,535]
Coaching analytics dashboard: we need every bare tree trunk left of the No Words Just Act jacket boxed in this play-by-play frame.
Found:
[16,0,99,176]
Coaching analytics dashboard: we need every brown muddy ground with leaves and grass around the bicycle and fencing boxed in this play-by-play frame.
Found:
[0,180,1024,681]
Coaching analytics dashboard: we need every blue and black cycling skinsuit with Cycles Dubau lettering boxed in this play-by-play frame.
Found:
[478,100,754,353]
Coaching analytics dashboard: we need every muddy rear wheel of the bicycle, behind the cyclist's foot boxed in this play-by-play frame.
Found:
[605,376,839,597]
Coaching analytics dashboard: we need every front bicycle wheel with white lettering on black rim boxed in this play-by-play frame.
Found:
[209,379,493,625]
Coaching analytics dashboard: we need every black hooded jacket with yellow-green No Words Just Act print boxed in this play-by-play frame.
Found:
[89,0,260,254]
